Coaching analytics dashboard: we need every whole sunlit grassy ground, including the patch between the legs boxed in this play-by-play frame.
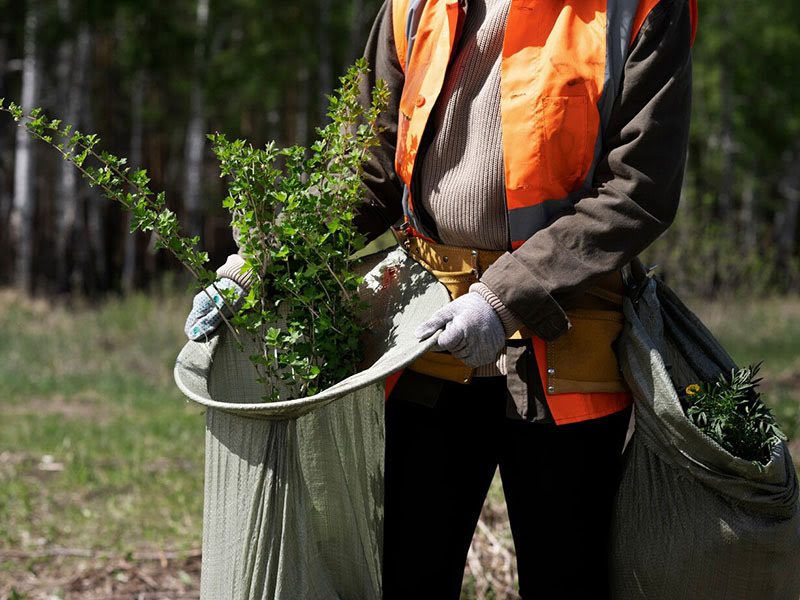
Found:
[0,285,800,600]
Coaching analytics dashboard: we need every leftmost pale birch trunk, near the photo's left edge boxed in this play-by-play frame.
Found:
[11,2,39,292]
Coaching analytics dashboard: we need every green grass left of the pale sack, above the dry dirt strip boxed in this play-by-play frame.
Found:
[0,282,204,598]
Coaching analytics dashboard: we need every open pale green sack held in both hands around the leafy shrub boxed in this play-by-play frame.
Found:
[175,248,450,600]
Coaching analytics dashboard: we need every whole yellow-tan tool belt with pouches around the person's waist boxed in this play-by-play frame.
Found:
[395,231,627,393]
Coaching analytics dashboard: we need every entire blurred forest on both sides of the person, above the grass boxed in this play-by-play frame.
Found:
[0,0,800,296]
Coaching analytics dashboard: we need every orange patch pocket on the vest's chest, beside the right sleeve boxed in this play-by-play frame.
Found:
[541,96,589,188]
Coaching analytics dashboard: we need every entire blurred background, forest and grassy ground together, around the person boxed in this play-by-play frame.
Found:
[0,0,800,600]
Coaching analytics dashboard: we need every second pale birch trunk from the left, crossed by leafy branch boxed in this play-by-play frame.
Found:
[55,17,91,292]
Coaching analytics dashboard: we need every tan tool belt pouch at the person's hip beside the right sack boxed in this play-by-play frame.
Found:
[546,309,628,394]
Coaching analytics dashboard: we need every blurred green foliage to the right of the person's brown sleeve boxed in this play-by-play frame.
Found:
[647,0,800,296]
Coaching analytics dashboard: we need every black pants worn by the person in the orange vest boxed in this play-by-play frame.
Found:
[383,377,630,600]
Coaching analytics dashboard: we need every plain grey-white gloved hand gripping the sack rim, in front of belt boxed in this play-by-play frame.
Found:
[414,292,506,367]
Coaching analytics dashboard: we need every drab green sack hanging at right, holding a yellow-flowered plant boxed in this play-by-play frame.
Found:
[610,279,800,600]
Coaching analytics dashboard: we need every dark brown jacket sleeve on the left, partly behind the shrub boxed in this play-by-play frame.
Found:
[355,0,405,240]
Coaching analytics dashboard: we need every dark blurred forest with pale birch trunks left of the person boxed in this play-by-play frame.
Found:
[0,0,379,296]
